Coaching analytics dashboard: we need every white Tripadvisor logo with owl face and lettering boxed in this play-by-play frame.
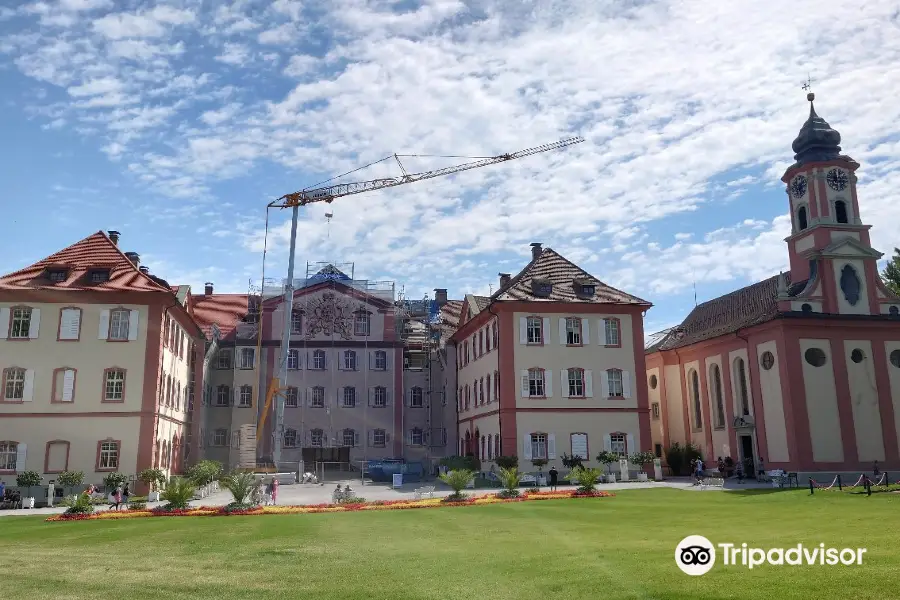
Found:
[675,535,866,576]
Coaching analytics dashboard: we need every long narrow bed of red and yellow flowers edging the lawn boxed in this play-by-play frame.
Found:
[47,490,613,521]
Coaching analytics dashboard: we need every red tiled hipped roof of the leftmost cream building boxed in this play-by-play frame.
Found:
[0,231,172,294]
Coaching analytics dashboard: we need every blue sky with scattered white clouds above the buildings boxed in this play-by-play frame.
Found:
[0,0,900,331]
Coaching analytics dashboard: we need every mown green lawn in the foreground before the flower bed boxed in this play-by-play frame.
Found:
[0,490,900,600]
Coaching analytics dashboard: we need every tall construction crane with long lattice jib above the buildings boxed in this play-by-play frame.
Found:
[256,136,584,468]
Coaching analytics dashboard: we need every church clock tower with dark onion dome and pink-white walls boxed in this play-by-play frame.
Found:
[778,93,900,315]
